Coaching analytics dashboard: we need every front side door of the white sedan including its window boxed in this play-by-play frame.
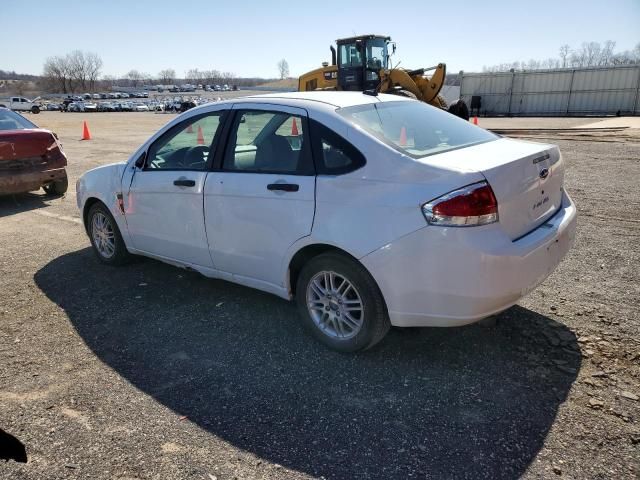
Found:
[125,111,223,267]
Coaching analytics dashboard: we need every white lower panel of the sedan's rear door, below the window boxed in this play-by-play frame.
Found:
[204,172,315,285]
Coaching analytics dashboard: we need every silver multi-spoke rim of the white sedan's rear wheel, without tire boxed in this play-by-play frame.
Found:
[307,271,364,340]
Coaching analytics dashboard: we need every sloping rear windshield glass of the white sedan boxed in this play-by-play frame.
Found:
[338,101,498,158]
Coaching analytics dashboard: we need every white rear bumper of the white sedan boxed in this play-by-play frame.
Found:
[361,188,576,327]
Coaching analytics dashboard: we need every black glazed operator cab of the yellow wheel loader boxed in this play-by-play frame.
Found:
[336,35,391,91]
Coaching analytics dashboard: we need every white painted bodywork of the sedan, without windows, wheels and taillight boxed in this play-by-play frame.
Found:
[78,92,576,326]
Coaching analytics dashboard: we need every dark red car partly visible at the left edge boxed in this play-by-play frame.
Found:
[0,108,68,195]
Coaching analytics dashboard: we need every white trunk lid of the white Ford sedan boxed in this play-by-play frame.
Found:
[422,138,565,240]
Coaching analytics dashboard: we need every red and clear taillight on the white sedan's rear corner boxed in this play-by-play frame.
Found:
[422,182,498,227]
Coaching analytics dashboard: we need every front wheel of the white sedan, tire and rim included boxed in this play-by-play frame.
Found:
[87,202,131,265]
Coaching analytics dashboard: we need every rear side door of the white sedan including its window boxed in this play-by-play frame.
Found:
[204,103,315,286]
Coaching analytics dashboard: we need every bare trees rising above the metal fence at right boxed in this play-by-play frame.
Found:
[482,40,640,72]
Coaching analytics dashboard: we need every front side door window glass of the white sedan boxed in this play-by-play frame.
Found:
[146,112,222,170]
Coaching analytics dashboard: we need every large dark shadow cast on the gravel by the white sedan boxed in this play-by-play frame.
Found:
[35,248,581,479]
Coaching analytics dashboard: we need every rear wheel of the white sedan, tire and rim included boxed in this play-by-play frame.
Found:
[296,252,390,352]
